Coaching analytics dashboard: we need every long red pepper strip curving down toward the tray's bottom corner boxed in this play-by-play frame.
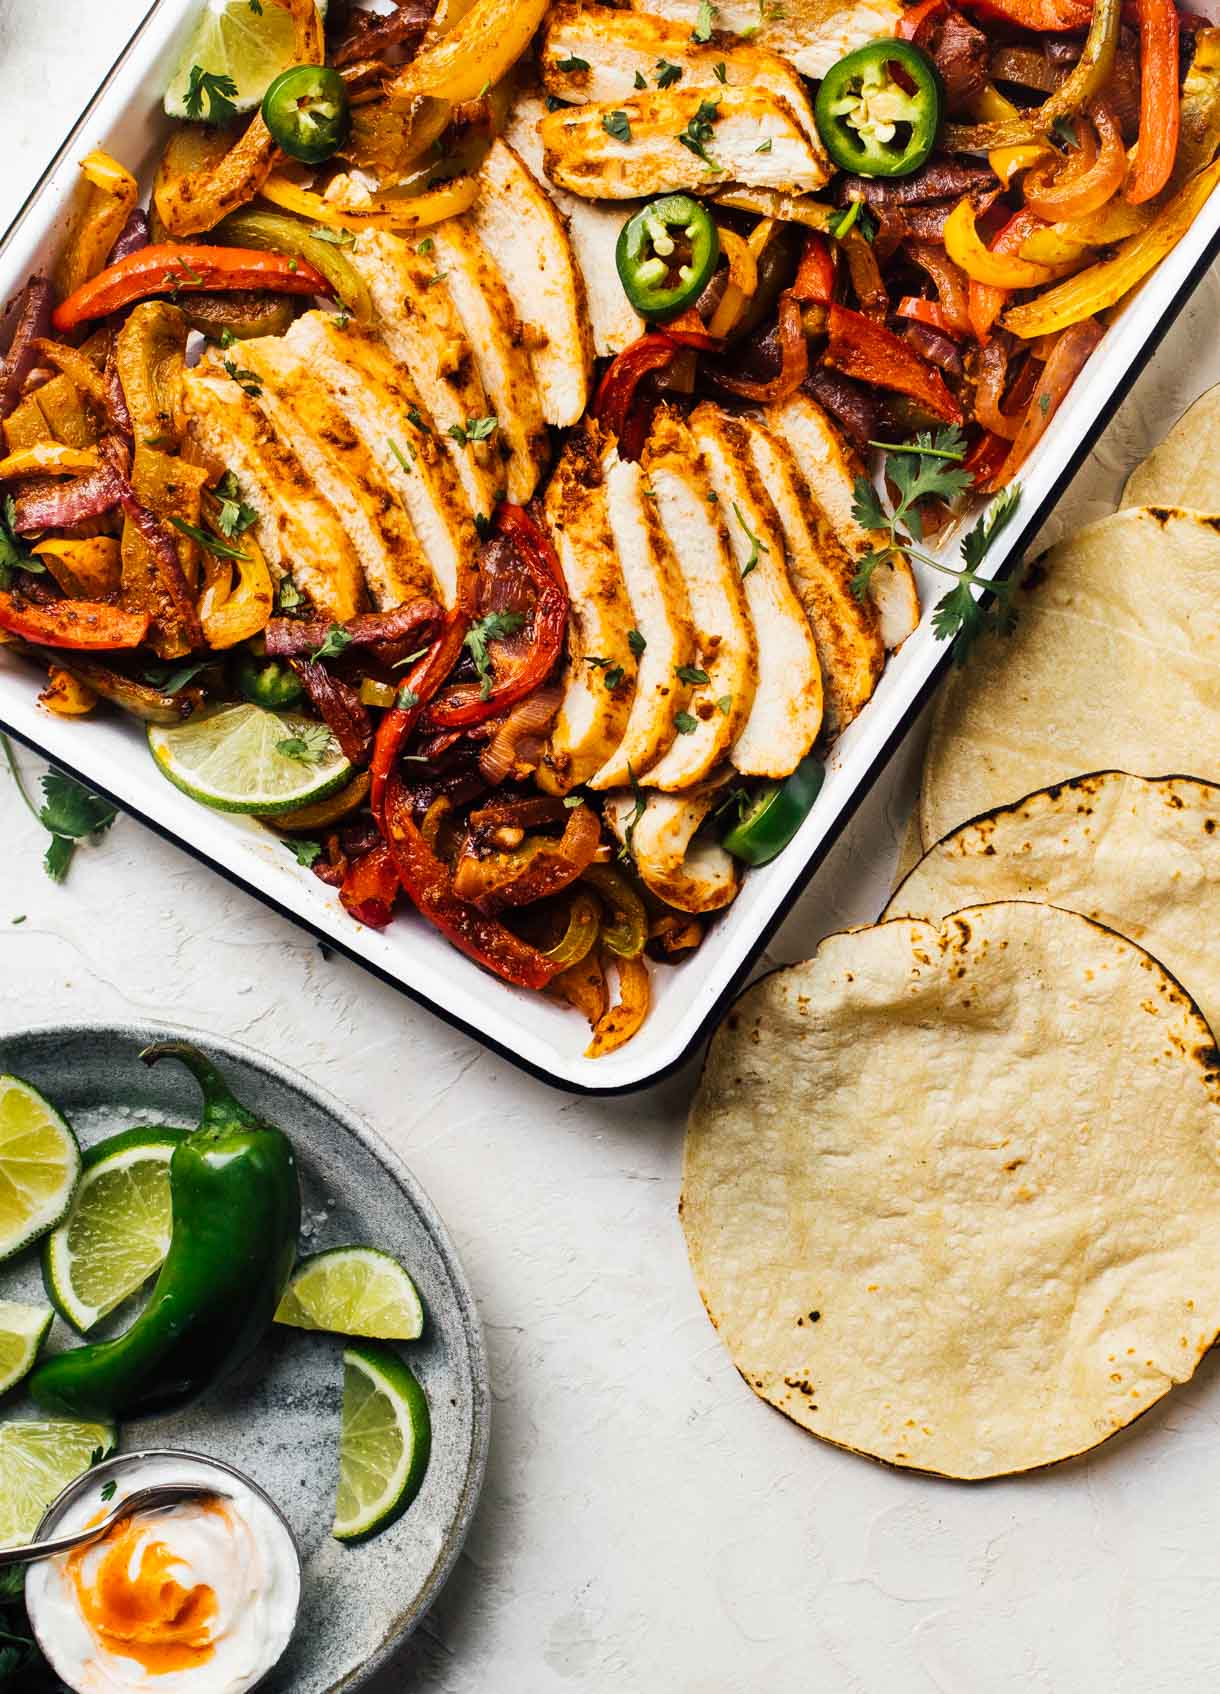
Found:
[383,771,563,989]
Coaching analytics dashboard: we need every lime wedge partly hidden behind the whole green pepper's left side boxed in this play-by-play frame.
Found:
[42,1123,186,1335]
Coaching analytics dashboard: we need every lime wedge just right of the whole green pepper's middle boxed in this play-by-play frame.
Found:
[276,1247,424,1342]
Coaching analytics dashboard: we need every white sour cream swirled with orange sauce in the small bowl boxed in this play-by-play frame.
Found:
[25,1455,300,1694]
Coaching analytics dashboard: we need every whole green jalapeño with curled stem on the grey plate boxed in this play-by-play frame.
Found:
[29,1042,300,1420]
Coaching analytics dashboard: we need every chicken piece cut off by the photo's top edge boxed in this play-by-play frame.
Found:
[632,0,903,81]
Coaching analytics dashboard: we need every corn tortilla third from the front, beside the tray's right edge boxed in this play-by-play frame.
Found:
[920,507,1220,847]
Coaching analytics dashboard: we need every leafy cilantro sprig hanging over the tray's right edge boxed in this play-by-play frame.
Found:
[852,427,1020,664]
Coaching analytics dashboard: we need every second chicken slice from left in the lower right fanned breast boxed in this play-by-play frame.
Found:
[588,451,695,788]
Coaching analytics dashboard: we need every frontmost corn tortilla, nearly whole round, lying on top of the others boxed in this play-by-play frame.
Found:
[683,901,1220,1479]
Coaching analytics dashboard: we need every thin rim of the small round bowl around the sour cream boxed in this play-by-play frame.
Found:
[25,1447,302,1694]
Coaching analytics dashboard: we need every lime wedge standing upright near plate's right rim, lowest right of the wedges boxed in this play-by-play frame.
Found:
[330,1342,432,1542]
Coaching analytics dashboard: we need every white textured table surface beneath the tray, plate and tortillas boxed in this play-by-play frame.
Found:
[0,0,1220,1694]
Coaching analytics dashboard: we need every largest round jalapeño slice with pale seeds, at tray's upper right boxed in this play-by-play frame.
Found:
[813,41,944,176]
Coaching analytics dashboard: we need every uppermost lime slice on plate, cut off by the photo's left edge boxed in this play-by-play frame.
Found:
[0,1076,80,1259]
